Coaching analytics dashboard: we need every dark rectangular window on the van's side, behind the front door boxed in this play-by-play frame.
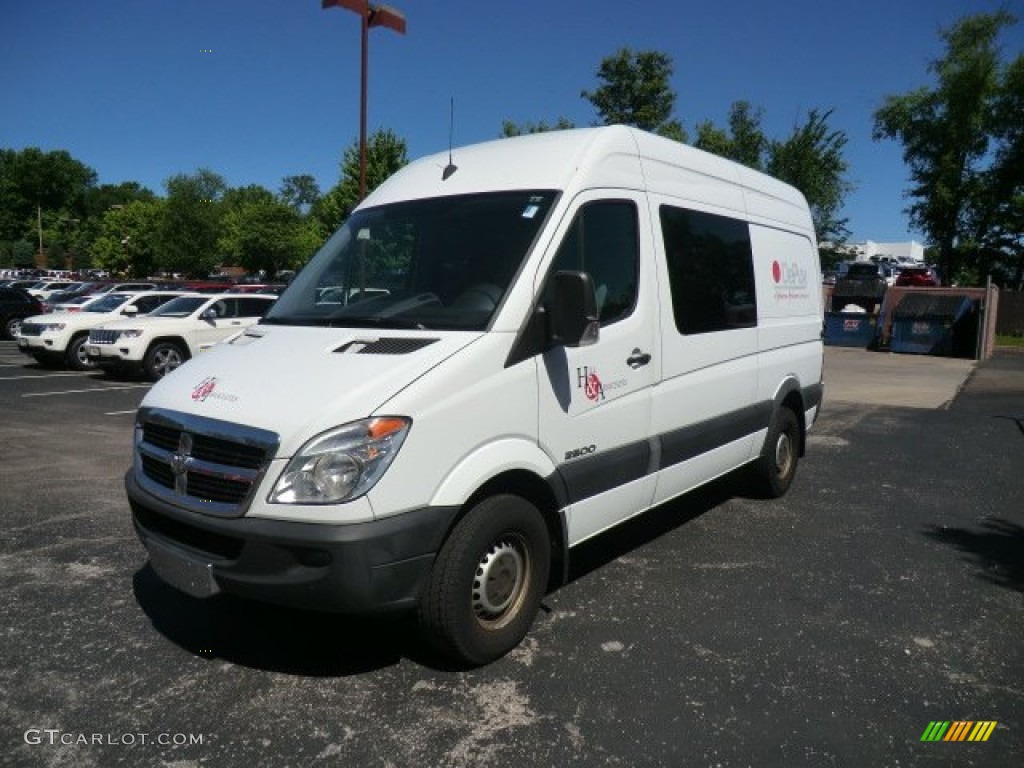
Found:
[659,206,758,335]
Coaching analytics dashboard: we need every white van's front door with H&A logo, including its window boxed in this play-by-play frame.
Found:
[538,195,660,545]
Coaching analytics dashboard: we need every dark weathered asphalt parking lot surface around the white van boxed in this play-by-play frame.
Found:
[0,342,1024,768]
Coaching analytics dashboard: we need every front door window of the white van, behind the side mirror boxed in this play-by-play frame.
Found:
[547,200,640,327]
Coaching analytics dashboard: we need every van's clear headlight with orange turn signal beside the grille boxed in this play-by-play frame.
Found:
[269,416,413,504]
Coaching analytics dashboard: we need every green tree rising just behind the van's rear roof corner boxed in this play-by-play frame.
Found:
[765,110,853,243]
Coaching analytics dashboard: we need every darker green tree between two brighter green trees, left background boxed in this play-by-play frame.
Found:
[156,168,227,276]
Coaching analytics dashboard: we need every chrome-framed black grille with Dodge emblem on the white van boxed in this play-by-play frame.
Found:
[135,409,280,517]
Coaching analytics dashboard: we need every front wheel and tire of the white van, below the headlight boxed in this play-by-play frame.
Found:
[417,496,551,666]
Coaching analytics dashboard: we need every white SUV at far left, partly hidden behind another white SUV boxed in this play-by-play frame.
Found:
[17,291,187,371]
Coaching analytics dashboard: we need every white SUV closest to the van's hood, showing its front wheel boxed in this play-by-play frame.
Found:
[86,293,278,381]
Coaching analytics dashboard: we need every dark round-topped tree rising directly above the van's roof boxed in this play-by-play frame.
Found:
[580,48,686,141]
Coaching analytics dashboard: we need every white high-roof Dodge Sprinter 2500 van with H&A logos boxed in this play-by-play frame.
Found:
[126,126,822,664]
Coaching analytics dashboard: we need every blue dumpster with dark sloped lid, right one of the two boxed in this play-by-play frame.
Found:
[889,294,972,356]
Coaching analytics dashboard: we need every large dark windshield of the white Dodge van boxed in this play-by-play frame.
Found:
[264,191,556,331]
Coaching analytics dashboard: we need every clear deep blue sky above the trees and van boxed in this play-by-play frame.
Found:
[0,0,1024,242]
